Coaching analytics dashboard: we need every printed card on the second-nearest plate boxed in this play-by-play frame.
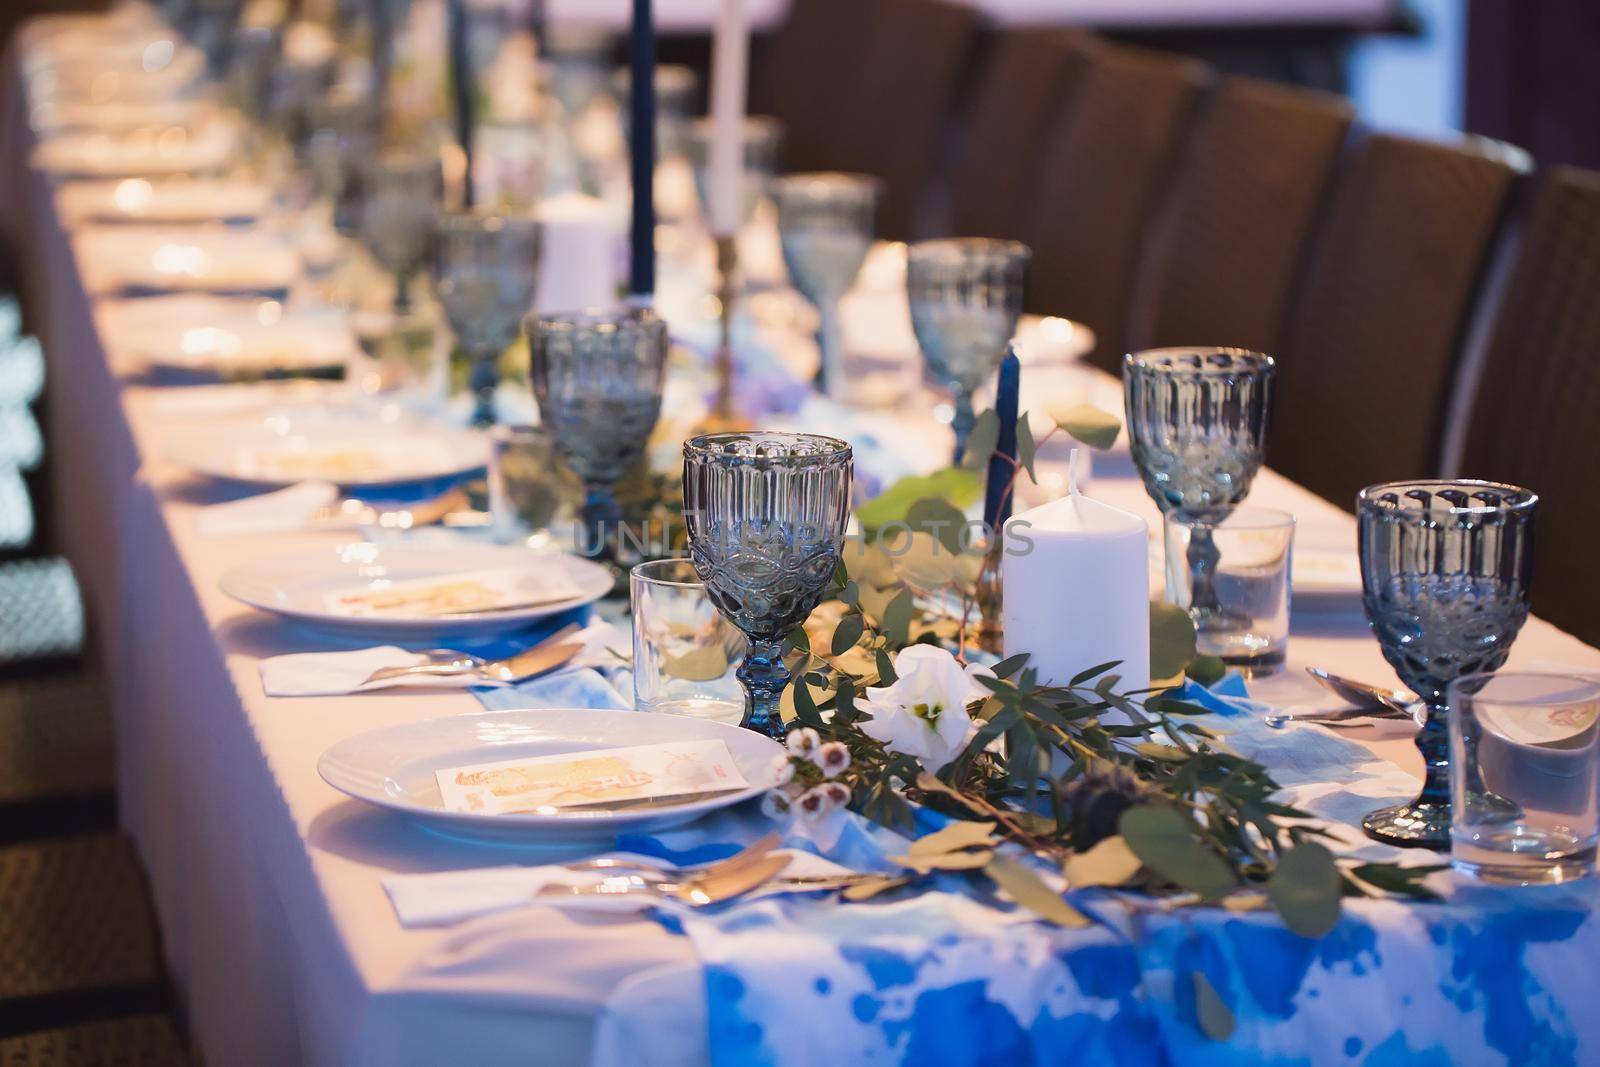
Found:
[326,558,582,619]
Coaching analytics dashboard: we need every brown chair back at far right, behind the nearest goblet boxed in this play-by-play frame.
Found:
[1456,168,1600,645]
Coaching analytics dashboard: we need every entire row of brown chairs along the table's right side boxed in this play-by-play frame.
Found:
[752,0,1600,643]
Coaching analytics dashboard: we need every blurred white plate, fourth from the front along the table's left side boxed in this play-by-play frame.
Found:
[104,293,355,378]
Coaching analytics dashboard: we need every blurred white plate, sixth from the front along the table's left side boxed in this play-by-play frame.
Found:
[56,178,272,222]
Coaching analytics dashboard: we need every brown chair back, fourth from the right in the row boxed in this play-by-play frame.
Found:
[1022,45,1210,370]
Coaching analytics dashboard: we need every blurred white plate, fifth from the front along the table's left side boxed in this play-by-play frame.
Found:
[75,226,299,296]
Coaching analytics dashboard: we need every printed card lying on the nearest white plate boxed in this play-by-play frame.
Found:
[435,741,749,814]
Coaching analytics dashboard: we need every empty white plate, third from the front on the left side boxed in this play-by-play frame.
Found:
[165,411,490,490]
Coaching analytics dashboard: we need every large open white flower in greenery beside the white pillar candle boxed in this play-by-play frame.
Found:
[861,645,990,771]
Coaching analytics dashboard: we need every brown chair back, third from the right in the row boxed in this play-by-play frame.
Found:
[1130,78,1352,352]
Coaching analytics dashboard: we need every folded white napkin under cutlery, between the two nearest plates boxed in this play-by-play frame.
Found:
[259,622,630,696]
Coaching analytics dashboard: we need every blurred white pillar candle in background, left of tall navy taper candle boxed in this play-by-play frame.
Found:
[533,194,622,312]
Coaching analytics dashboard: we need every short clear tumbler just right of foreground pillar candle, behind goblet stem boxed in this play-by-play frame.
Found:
[1165,507,1294,677]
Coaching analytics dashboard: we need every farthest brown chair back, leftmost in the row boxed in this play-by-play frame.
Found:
[752,0,981,238]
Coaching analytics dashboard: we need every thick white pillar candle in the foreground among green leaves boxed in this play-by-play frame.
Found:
[1000,450,1150,693]
